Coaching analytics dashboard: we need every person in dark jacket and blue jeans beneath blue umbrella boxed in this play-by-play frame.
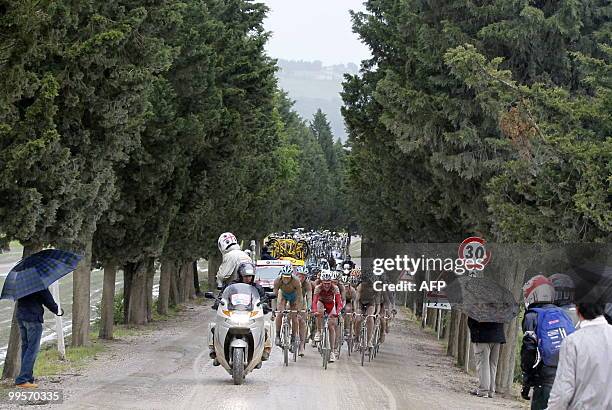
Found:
[15,289,63,388]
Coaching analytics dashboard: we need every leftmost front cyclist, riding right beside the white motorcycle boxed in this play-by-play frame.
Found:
[274,265,302,346]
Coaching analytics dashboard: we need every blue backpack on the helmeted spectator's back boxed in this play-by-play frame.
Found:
[529,308,576,367]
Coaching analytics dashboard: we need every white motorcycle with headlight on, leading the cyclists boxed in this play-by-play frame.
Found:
[205,283,266,384]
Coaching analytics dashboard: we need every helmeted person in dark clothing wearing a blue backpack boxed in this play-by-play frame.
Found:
[521,275,575,410]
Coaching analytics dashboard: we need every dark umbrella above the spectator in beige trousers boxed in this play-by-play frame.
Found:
[445,276,519,323]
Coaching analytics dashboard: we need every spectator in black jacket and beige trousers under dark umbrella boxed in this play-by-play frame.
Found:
[468,318,506,398]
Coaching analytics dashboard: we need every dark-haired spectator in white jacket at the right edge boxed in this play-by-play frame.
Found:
[548,303,612,410]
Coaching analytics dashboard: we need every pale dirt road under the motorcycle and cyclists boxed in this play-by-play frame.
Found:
[17,300,521,410]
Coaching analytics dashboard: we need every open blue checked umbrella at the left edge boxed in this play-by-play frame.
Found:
[0,249,82,300]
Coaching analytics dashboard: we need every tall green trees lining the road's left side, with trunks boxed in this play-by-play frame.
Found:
[0,0,345,377]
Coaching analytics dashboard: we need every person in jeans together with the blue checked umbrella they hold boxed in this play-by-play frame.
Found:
[0,249,81,388]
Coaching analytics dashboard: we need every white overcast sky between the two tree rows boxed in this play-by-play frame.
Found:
[261,0,369,65]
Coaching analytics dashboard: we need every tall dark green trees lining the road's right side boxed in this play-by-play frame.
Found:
[343,0,612,391]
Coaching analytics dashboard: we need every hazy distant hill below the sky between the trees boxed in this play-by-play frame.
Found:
[277,59,359,141]
